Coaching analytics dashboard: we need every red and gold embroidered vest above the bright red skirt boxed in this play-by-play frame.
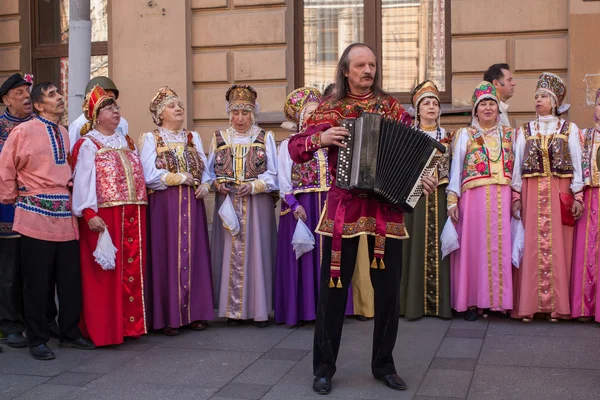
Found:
[90,136,148,208]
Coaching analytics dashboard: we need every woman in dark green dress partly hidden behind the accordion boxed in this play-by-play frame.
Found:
[400,81,452,320]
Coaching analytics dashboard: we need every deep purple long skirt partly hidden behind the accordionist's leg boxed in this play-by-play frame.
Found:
[275,192,354,326]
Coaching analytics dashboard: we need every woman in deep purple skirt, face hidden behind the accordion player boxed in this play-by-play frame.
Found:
[275,87,353,326]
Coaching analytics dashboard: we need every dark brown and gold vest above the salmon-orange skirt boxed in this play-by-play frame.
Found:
[522,121,573,178]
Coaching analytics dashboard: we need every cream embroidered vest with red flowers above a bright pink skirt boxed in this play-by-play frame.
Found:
[462,126,515,192]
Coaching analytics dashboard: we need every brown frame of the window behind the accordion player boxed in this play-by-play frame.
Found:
[293,0,452,103]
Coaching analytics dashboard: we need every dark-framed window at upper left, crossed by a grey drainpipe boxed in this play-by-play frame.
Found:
[31,0,108,122]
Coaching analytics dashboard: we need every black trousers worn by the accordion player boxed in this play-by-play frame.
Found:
[313,236,402,378]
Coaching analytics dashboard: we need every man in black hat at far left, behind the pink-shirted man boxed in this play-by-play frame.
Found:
[0,74,33,347]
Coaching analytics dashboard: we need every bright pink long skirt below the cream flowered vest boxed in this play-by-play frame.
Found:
[450,185,513,312]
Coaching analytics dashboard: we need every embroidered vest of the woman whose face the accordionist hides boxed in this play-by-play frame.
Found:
[292,149,331,194]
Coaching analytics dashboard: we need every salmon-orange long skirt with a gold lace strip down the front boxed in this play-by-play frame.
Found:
[511,176,574,318]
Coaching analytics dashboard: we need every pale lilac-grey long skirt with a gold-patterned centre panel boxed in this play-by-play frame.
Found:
[212,193,277,321]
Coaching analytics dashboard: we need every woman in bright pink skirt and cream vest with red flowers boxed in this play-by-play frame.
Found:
[446,82,514,321]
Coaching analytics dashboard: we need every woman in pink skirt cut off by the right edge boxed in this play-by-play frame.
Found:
[571,89,600,322]
